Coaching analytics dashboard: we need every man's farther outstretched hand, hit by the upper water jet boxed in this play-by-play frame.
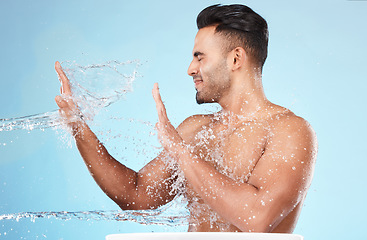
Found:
[55,61,83,131]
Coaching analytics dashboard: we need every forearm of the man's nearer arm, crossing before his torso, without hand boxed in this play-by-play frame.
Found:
[178,150,266,231]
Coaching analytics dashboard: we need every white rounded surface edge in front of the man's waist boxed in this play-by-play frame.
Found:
[106,232,303,240]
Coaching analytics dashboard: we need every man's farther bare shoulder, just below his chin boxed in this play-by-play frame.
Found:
[176,114,213,141]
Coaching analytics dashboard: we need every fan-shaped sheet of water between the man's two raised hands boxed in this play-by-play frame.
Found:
[62,61,140,115]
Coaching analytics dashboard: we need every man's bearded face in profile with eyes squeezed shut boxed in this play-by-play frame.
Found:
[188,26,230,104]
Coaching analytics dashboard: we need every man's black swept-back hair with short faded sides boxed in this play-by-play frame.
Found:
[196,4,269,67]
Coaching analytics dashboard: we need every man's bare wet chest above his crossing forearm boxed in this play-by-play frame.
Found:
[190,122,269,182]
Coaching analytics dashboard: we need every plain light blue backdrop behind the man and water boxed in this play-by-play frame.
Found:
[0,0,367,239]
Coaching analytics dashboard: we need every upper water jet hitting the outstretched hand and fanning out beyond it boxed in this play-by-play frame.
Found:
[0,60,140,132]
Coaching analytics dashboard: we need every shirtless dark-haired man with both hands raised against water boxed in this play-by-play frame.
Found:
[55,5,317,233]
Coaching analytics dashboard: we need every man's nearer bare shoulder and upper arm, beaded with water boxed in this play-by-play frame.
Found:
[248,111,317,194]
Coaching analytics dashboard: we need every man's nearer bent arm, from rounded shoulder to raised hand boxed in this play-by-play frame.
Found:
[153,83,317,232]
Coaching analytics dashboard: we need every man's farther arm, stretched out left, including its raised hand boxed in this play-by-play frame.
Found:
[55,62,175,209]
